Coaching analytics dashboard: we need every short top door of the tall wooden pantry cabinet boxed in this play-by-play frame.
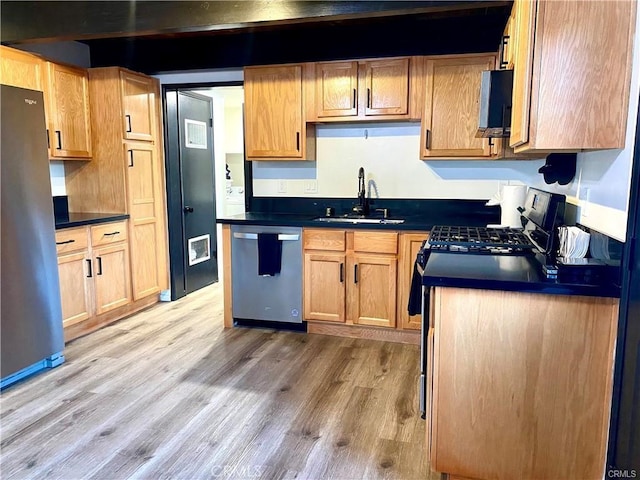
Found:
[120,72,155,141]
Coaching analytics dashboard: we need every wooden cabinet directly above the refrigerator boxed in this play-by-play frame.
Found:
[0,46,44,91]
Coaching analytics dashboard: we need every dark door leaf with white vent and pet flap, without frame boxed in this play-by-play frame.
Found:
[178,92,218,293]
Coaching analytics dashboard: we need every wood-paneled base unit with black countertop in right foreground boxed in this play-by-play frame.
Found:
[423,253,619,479]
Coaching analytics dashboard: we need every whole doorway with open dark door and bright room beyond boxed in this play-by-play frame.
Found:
[163,83,251,300]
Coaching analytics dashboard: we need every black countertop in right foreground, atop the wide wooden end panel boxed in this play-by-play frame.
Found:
[422,252,620,298]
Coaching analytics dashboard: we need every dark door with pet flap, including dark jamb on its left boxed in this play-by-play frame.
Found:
[164,88,218,300]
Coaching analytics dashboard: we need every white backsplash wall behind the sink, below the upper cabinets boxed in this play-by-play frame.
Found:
[252,122,544,199]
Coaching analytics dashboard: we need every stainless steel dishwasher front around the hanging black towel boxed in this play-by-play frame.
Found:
[231,225,302,323]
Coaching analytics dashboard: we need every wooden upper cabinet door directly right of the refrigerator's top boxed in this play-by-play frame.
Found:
[47,62,91,158]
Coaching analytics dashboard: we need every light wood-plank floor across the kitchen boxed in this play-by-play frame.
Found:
[0,284,439,480]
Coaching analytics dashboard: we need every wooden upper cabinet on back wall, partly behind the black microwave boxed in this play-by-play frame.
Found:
[420,54,496,159]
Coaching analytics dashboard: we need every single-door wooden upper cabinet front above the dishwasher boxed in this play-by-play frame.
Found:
[244,65,305,158]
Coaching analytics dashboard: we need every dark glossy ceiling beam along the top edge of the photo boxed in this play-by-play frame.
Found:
[0,0,512,44]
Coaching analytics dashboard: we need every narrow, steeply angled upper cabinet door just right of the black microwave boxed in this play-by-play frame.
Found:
[509,0,538,147]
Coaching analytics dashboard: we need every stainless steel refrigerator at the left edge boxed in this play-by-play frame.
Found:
[0,85,64,388]
